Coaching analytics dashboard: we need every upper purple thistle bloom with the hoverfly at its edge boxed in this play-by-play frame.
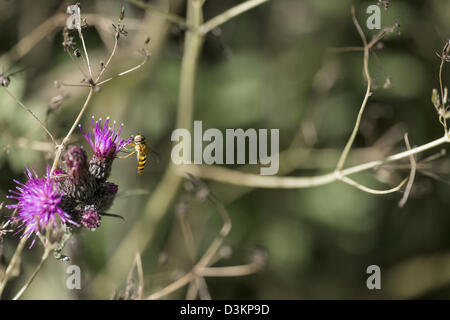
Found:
[79,116,132,158]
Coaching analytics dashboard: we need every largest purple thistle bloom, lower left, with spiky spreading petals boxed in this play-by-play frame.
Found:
[6,167,78,247]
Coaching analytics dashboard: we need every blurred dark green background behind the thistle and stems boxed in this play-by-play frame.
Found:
[0,0,450,299]
